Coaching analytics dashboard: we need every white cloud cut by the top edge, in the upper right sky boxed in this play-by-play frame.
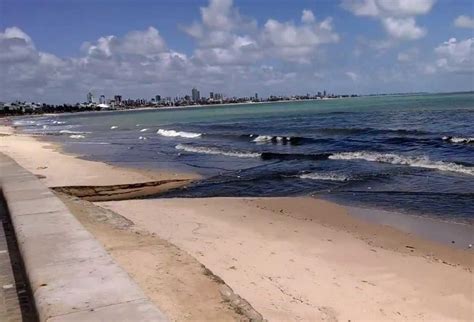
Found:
[341,0,435,40]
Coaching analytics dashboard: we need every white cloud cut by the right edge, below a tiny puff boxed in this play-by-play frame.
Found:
[435,38,474,73]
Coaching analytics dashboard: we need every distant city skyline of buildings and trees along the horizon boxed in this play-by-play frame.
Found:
[0,87,357,116]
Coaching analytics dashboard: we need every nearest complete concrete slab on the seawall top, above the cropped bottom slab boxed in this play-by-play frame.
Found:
[30,257,146,320]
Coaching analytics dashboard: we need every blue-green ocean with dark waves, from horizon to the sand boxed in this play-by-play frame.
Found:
[14,93,474,225]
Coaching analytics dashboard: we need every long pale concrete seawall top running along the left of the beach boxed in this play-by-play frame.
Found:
[0,153,167,321]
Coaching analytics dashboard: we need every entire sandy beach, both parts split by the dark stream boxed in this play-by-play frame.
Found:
[0,122,474,321]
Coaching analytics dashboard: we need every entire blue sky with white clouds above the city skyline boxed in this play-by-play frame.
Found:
[0,0,474,103]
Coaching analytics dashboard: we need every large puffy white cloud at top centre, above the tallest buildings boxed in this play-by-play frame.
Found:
[182,0,339,65]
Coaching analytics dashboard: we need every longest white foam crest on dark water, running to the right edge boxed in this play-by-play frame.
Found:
[329,151,474,175]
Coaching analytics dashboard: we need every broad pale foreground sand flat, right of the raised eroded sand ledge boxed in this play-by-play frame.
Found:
[100,198,474,321]
